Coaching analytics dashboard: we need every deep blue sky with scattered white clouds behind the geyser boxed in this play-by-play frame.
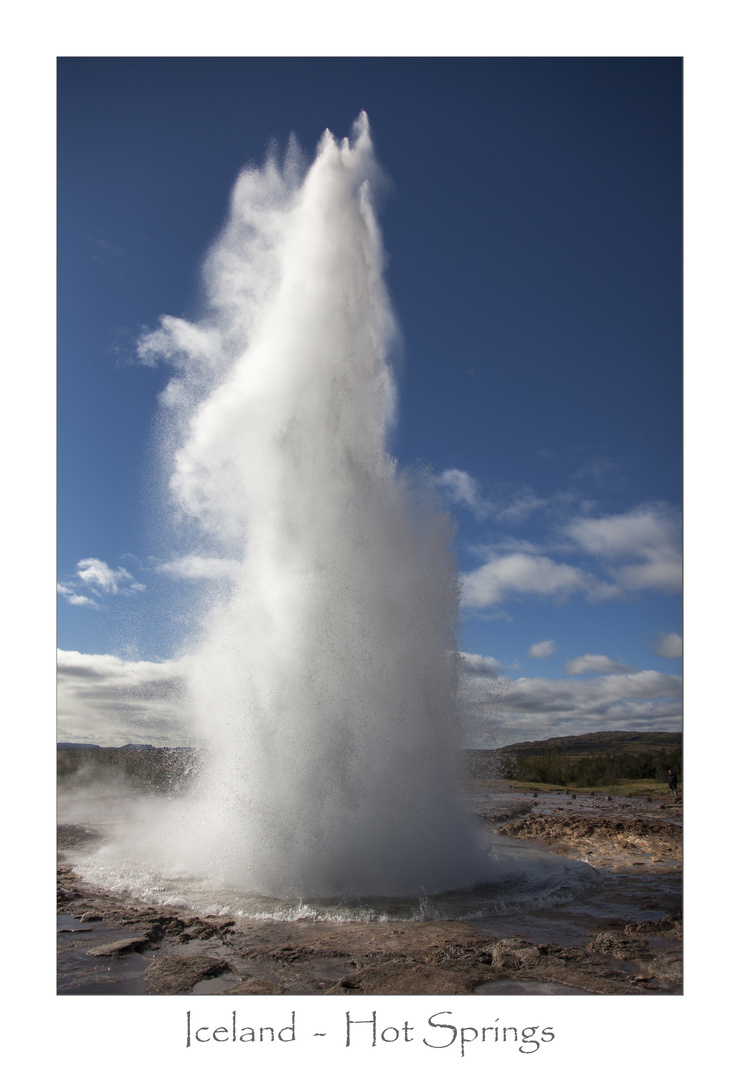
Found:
[58,58,682,743]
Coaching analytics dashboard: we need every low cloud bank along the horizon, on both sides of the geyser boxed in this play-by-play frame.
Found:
[57,649,682,747]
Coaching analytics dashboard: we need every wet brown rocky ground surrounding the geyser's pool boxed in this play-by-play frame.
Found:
[58,792,682,995]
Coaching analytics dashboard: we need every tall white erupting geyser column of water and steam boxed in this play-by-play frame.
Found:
[146,113,483,897]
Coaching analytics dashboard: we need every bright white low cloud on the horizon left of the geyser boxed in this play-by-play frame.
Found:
[57,649,190,746]
